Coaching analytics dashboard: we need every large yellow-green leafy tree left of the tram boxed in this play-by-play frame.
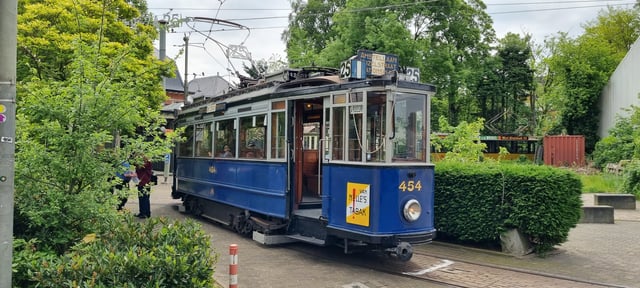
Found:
[14,0,172,254]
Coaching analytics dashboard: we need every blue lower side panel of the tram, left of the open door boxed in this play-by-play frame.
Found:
[176,158,287,218]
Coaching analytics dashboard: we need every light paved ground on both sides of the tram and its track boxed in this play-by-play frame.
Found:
[127,181,640,288]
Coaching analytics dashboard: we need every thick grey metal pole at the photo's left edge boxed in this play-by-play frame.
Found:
[0,0,18,287]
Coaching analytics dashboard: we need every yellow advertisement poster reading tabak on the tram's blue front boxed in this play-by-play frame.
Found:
[346,182,371,227]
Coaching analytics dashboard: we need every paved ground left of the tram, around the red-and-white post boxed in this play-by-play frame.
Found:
[125,181,449,288]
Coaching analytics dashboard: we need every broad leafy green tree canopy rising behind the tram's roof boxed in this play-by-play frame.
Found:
[285,0,494,125]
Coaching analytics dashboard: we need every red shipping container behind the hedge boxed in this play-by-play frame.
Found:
[542,135,585,167]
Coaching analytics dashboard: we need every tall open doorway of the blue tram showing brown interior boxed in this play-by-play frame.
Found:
[293,98,323,209]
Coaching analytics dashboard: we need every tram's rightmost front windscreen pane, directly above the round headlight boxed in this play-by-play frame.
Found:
[393,94,427,162]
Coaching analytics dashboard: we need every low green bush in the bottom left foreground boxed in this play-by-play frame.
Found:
[14,215,217,288]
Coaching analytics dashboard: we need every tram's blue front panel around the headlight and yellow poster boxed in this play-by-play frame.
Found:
[322,164,435,235]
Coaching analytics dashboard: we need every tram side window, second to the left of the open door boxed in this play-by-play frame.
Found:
[238,115,267,159]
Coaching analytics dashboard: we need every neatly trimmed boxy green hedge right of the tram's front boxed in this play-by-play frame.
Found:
[435,161,582,254]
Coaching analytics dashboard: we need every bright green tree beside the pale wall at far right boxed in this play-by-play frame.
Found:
[543,7,640,153]
